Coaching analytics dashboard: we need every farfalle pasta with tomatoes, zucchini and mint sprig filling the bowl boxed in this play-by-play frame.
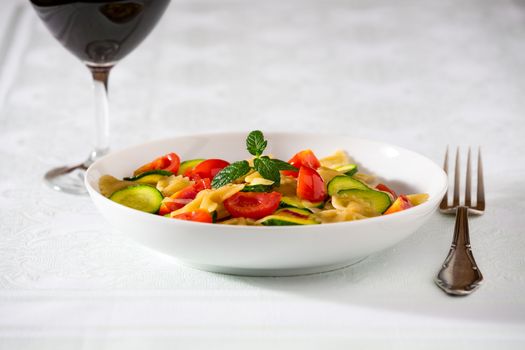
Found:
[99,131,428,226]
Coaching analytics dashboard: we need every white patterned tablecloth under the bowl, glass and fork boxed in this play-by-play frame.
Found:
[0,0,525,349]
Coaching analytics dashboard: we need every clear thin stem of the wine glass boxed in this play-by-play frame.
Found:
[85,66,112,166]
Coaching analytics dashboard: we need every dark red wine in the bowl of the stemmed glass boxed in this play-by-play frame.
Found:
[31,0,170,65]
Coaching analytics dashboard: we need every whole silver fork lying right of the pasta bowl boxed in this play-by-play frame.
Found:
[434,148,485,295]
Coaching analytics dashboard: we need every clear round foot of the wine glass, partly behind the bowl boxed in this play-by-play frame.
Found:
[44,164,87,194]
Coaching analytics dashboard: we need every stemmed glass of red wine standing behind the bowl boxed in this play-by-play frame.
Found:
[30,0,170,194]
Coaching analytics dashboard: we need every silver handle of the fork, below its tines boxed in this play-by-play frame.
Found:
[435,206,483,295]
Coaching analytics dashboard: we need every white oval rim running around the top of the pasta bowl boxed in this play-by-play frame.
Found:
[84,131,448,234]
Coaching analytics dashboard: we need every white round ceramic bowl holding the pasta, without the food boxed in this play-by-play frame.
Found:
[86,133,447,276]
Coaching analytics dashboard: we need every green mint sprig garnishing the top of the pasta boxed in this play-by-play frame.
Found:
[211,130,298,188]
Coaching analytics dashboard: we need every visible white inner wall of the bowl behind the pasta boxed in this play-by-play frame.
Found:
[86,133,446,198]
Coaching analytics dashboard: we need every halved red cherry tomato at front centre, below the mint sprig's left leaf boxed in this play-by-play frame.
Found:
[224,192,281,220]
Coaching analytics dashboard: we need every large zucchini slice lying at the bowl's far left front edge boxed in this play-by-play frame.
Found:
[109,185,163,213]
